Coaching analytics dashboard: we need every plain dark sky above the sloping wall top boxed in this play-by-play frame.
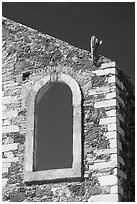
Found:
[2,2,135,84]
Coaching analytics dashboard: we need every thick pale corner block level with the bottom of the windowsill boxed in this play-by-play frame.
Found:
[98,175,118,186]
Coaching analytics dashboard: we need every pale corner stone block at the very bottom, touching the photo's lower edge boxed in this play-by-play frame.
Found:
[88,194,119,202]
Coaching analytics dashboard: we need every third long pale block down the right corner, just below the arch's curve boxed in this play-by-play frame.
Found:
[94,99,119,108]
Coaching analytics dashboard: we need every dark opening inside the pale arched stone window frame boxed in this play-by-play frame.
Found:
[33,82,73,171]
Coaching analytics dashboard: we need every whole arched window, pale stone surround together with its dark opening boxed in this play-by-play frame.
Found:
[24,74,81,182]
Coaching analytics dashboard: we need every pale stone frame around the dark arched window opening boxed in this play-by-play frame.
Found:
[24,74,82,182]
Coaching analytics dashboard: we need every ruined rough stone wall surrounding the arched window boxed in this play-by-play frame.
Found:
[2,18,134,202]
